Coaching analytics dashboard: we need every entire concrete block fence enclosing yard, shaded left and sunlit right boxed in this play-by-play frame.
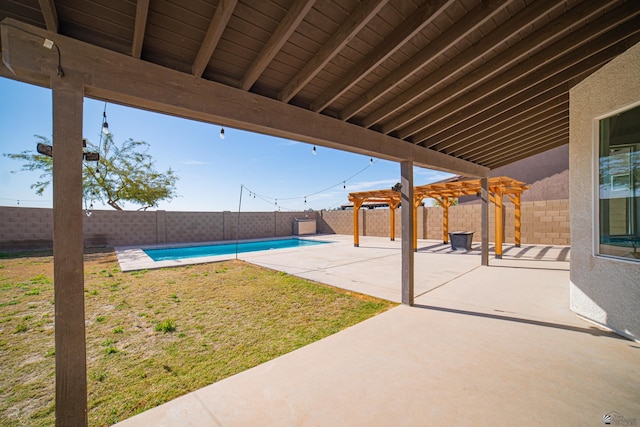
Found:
[0,200,570,251]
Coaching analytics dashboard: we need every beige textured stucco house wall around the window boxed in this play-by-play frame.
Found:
[569,40,640,340]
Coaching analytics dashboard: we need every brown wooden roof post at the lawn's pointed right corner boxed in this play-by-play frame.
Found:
[400,160,415,305]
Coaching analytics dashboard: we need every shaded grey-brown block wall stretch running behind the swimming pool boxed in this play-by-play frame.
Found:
[0,207,318,251]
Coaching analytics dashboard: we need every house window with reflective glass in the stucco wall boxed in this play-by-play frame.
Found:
[597,106,640,261]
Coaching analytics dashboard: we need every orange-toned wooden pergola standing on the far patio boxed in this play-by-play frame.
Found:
[349,176,529,258]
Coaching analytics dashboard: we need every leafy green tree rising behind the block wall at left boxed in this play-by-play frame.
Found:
[4,133,178,210]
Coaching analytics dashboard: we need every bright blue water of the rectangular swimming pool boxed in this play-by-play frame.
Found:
[144,239,329,261]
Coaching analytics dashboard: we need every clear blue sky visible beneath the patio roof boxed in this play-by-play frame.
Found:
[0,77,450,211]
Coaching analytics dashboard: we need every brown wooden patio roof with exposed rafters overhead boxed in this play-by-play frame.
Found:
[0,0,640,172]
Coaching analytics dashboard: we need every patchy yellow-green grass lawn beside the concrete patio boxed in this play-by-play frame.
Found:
[0,252,395,426]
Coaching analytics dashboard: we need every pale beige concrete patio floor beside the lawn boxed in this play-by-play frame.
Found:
[117,236,640,427]
